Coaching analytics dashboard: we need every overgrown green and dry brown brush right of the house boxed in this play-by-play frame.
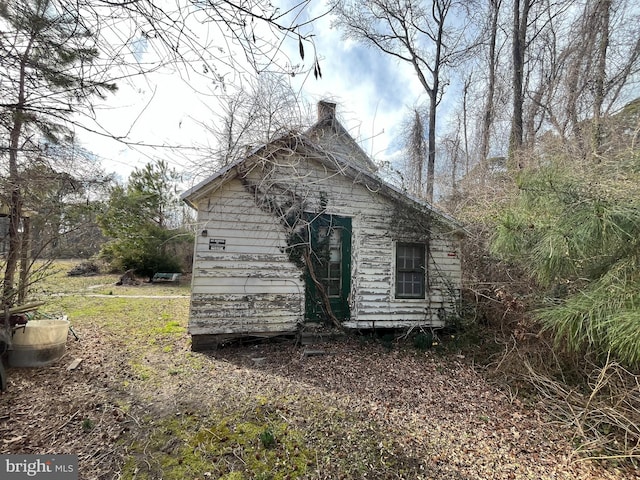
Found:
[458,142,640,462]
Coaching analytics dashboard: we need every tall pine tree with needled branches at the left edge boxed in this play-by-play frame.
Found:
[0,0,116,312]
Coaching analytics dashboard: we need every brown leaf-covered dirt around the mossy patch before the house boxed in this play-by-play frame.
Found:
[0,320,640,479]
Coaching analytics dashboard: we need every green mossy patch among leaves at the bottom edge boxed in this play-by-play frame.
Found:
[122,415,312,480]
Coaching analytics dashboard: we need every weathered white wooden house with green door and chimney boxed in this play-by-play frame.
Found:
[182,102,462,350]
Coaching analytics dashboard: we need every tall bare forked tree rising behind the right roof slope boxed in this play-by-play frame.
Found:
[333,0,478,201]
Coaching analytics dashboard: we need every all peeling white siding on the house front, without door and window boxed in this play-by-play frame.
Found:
[189,148,461,344]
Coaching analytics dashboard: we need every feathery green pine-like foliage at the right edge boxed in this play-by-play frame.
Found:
[492,154,640,367]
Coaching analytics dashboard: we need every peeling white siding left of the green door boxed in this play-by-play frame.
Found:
[189,180,304,342]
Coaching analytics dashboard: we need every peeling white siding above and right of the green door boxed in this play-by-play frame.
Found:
[242,157,461,328]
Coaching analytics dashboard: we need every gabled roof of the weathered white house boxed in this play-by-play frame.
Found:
[180,104,465,234]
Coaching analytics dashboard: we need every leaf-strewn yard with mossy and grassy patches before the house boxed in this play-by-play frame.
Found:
[0,272,640,480]
